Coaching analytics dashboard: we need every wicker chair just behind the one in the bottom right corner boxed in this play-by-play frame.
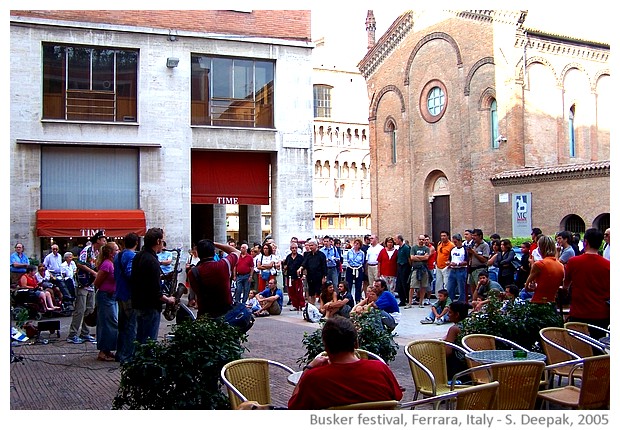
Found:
[540,327,606,388]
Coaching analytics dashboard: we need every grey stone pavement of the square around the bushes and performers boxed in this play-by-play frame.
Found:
[10,296,448,410]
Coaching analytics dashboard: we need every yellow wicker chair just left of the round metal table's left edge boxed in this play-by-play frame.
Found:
[405,339,467,408]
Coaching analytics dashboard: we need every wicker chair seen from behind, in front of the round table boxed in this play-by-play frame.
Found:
[450,360,545,410]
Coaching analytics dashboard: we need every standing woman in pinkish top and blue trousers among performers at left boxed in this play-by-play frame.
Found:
[93,242,118,361]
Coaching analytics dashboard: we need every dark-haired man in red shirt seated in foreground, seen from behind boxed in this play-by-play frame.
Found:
[288,316,403,410]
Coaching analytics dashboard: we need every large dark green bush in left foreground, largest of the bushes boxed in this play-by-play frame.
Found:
[112,318,247,409]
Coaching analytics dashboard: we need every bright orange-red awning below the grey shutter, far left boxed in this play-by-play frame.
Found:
[37,209,146,237]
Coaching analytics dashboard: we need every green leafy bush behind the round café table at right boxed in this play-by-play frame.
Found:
[457,292,563,351]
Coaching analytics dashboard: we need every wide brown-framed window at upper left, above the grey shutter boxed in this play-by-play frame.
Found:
[43,43,138,122]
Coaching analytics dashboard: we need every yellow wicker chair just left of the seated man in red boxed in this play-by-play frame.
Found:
[220,358,295,409]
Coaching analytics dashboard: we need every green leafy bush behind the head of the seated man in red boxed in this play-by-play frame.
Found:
[297,309,398,366]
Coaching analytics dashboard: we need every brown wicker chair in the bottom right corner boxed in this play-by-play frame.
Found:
[538,355,611,409]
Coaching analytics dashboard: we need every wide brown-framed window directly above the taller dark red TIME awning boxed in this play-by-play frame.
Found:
[191,54,274,128]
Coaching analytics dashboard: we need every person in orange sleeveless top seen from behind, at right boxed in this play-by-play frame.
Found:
[525,235,564,304]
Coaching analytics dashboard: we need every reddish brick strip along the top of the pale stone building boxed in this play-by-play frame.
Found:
[11,10,311,41]
